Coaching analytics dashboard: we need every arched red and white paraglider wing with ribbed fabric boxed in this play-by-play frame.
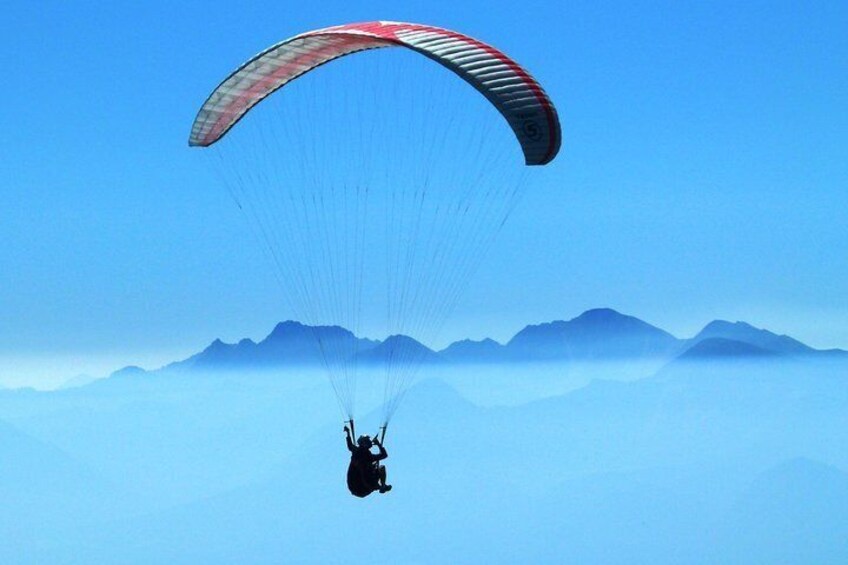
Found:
[189,22,560,165]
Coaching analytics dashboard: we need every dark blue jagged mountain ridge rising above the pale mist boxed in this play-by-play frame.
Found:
[116,308,848,374]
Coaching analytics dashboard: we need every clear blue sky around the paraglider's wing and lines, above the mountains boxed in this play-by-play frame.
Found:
[0,1,848,384]
